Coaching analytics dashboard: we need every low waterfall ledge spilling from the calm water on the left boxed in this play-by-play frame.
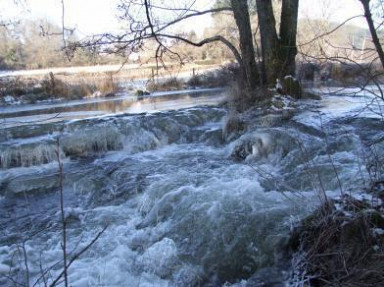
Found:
[0,109,226,169]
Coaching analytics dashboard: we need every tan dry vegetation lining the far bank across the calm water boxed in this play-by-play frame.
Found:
[0,62,225,105]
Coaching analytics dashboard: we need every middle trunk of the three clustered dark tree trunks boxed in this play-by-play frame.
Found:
[256,0,280,84]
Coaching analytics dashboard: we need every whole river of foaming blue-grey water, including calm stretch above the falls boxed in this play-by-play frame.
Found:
[0,91,384,287]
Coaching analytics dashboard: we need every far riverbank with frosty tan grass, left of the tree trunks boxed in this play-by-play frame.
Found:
[0,64,232,106]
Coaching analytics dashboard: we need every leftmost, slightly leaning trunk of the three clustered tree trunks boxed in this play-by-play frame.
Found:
[231,0,259,89]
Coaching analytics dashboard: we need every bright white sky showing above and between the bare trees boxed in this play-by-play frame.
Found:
[0,0,366,36]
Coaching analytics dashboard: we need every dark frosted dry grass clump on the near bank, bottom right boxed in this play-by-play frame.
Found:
[291,196,384,287]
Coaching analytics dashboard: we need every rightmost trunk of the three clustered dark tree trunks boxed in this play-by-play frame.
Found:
[280,0,299,76]
